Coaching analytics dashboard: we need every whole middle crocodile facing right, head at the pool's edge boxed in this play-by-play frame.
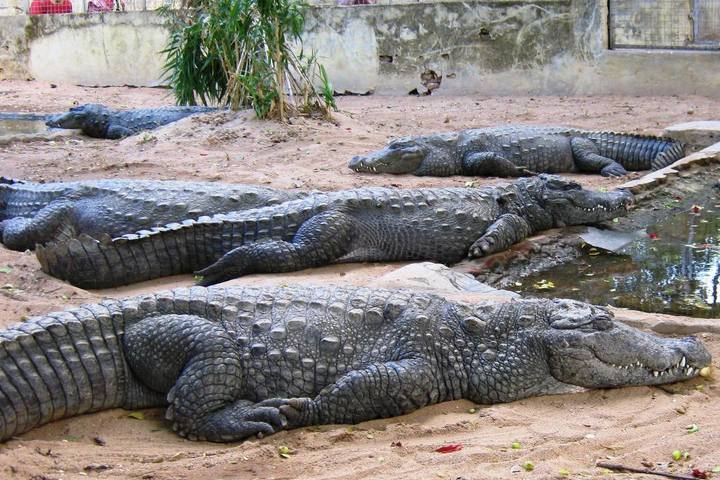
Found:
[36,175,633,288]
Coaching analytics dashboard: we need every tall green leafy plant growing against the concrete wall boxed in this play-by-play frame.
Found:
[162,0,336,120]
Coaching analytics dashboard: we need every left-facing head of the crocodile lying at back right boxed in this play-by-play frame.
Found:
[348,133,457,175]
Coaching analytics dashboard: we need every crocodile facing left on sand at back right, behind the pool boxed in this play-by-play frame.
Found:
[348,125,684,177]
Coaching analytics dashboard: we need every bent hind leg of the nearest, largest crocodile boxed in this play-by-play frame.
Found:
[123,315,286,442]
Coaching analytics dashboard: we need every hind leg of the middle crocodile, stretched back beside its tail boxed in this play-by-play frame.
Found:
[197,211,355,286]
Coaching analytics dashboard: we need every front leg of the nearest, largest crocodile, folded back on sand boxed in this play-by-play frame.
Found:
[280,359,438,428]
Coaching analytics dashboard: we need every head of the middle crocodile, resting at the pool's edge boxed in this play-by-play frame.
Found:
[517,175,633,227]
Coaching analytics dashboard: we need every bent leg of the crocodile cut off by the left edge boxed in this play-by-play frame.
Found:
[0,200,76,250]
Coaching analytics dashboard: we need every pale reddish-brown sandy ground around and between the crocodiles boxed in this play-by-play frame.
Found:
[0,82,720,480]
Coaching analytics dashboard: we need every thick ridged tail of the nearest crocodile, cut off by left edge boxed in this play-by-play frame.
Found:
[0,302,128,441]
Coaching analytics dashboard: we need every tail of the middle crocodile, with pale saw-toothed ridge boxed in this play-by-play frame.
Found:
[36,220,221,289]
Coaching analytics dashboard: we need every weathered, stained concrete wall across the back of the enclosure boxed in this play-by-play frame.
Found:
[0,0,720,96]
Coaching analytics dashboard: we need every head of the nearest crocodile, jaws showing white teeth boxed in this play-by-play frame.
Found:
[465,299,711,403]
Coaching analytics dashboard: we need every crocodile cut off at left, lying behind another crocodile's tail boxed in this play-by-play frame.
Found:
[0,178,303,250]
